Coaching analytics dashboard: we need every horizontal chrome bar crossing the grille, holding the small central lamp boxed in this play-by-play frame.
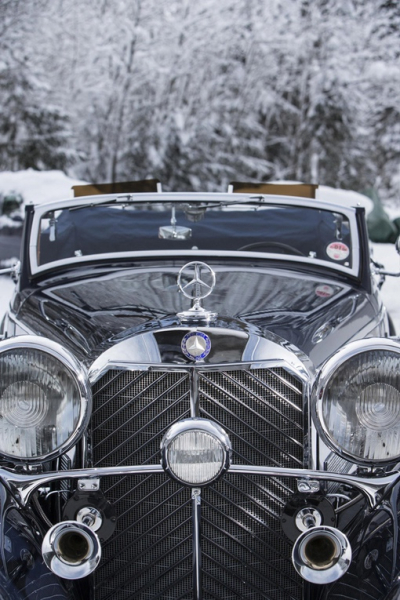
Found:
[0,465,400,508]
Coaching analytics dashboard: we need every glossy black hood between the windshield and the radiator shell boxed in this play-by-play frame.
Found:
[14,265,377,365]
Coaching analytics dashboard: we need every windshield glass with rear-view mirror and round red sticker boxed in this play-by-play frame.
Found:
[37,201,352,268]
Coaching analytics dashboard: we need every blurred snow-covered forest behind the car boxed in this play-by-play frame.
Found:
[0,0,400,204]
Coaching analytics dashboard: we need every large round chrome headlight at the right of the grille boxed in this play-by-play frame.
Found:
[317,338,400,464]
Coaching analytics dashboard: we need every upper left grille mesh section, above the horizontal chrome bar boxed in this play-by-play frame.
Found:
[92,371,190,467]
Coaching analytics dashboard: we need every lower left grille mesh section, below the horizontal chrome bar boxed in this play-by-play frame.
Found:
[95,475,192,600]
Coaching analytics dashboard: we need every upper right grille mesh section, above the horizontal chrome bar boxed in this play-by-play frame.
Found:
[200,369,303,467]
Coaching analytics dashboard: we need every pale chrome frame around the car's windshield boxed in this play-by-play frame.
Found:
[29,192,360,277]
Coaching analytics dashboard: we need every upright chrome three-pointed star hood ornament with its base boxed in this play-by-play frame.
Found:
[177,261,218,323]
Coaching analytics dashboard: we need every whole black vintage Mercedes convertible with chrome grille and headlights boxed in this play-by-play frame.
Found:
[0,181,400,600]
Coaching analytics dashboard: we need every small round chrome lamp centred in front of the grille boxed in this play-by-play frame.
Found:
[161,419,231,486]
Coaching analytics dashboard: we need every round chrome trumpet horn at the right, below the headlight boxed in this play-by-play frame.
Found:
[292,526,352,584]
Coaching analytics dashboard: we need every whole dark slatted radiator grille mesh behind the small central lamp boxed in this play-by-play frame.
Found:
[91,367,303,600]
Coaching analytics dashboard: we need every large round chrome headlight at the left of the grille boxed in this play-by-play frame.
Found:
[0,336,91,461]
